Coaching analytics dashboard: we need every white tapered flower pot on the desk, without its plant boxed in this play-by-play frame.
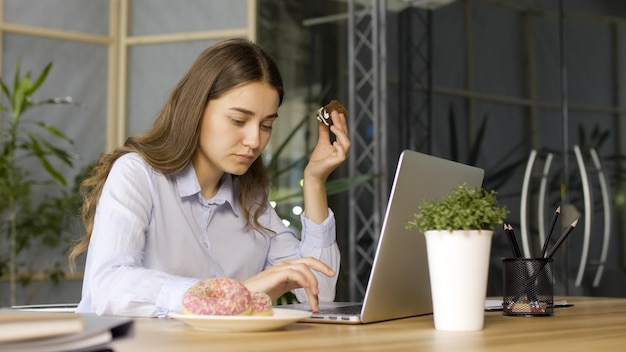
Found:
[424,230,493,331]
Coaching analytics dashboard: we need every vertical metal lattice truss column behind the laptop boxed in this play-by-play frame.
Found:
[348,0,386,300]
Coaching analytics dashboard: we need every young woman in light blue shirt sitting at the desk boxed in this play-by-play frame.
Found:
[70,39,350,317]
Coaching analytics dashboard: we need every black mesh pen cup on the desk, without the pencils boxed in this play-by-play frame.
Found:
[502,258,554,317]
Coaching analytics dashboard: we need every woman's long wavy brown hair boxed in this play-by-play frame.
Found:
[69,39,284,267]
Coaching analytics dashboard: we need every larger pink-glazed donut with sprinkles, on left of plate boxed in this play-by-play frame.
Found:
[182,277,252,315]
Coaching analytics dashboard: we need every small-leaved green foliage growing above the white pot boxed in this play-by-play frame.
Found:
[405,184,508,231]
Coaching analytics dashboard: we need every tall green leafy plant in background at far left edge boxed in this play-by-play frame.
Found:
[0,62,76,305]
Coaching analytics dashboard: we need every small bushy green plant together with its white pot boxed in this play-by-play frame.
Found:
[405,184,508,331]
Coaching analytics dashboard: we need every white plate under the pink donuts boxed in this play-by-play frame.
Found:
[168,308,311,332]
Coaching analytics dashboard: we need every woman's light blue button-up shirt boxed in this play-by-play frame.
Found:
[77,153,340,317]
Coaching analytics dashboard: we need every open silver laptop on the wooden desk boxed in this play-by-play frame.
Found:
[281,150,484,324]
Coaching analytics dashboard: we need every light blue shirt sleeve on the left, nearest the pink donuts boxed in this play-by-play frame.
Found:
[79,158,198,317]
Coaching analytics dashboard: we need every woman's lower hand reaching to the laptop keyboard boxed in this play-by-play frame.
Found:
[243,257,335,312]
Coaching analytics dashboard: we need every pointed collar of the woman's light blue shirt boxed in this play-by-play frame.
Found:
[175,163,239,216]
